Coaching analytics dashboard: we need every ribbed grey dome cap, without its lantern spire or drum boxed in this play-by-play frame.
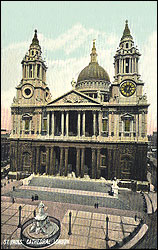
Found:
[77,62,110,83]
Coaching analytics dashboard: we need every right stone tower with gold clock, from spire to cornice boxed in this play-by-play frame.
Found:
[112,20,144,104]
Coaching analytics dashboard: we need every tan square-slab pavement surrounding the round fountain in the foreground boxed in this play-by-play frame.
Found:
[1,201,139,249]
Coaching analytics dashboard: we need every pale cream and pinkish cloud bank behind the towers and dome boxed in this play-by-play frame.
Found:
[1,24,157,135]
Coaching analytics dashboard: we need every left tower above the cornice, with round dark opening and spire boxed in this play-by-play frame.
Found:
[13,30,51,106]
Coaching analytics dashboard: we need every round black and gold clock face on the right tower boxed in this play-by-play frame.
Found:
[120,81,136,97]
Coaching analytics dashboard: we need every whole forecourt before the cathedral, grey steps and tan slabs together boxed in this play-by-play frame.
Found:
[1,178,157,249]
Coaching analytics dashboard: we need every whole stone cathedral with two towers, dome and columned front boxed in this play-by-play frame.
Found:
[10,21,149,181]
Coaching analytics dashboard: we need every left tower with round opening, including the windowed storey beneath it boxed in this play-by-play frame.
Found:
[11,30,51,138]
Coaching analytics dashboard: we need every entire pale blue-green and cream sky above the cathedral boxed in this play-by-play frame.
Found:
[1,1,157,134]
